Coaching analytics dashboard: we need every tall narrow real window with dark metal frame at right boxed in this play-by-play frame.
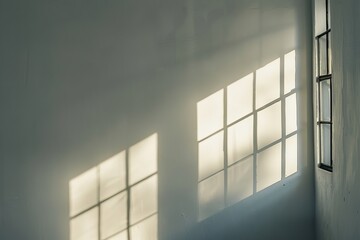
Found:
[315,0,333,171]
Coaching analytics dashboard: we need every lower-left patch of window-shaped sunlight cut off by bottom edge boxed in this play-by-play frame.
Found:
[69,133,158,240]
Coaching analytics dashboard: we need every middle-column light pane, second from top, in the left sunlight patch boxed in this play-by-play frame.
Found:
[100,192,127,239]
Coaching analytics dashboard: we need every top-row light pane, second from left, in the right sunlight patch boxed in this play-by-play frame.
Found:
[227,73,254,124]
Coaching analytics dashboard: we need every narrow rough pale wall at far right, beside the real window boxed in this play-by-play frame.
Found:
[316,0,360,240]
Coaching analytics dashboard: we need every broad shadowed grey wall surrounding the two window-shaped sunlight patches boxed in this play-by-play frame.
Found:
[0,0,314,240]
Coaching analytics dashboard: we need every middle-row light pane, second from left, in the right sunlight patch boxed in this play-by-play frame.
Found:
[227,116,254,165]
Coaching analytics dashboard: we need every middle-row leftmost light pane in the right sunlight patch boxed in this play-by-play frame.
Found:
[199,131,224,180]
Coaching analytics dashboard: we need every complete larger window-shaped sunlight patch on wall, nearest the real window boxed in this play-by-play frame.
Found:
[197,50,298,221]
